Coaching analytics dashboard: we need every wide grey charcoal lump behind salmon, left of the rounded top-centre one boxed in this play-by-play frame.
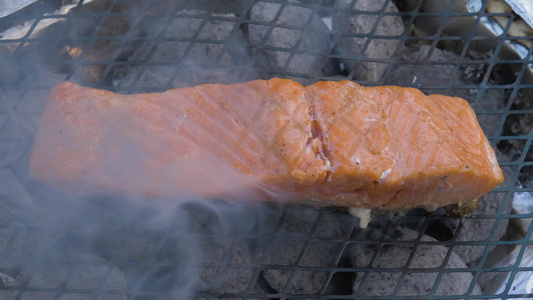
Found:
[118,10,258,91]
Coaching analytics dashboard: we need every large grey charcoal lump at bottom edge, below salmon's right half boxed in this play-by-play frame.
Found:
[344,226,480,296]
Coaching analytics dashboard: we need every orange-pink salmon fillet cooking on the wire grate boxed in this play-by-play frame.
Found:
[29,79,503,210]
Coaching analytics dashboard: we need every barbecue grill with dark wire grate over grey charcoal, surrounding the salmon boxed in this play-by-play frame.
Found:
[0,0,533,300]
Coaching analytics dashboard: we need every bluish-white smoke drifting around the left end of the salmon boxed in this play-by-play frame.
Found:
[0,1,268,300]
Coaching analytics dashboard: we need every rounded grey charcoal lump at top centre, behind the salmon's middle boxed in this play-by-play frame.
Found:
[247,1,336,85]
